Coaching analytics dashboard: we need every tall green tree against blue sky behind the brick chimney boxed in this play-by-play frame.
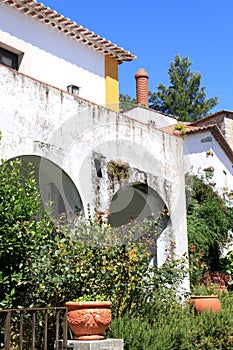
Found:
[149,55,218,121]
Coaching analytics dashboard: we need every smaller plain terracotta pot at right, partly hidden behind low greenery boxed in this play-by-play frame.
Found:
[189,295,221,312]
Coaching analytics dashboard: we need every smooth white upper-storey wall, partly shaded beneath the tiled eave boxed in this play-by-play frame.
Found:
[0,3,106,105]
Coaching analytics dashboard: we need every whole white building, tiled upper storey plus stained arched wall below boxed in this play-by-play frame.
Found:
[0,0,188,266]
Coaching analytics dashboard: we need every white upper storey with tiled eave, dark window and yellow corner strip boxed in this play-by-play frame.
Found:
[0,0,135,109]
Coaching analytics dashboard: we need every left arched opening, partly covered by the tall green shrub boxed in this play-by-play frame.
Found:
[8,155,83,218]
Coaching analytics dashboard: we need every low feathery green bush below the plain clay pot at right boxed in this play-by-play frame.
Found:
[107,291,233,350]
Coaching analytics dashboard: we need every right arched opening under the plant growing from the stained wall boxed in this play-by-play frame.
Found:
[108,183,170,265]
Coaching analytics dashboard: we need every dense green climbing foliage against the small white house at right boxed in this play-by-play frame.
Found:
[187,175,233,282]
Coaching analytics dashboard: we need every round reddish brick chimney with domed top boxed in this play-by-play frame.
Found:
[135,68,149,108]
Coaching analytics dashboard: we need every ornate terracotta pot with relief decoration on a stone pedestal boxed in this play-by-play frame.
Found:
[65,301,112,340]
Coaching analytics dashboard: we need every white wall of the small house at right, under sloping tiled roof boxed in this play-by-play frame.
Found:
[184,131,233,195]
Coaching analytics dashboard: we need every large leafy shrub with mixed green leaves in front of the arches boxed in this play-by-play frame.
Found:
[0,160,179,316]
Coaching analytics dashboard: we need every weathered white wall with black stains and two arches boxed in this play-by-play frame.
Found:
[0,66,187,274]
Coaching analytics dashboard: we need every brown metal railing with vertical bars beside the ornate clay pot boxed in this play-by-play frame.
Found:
[0,307,67,350]
